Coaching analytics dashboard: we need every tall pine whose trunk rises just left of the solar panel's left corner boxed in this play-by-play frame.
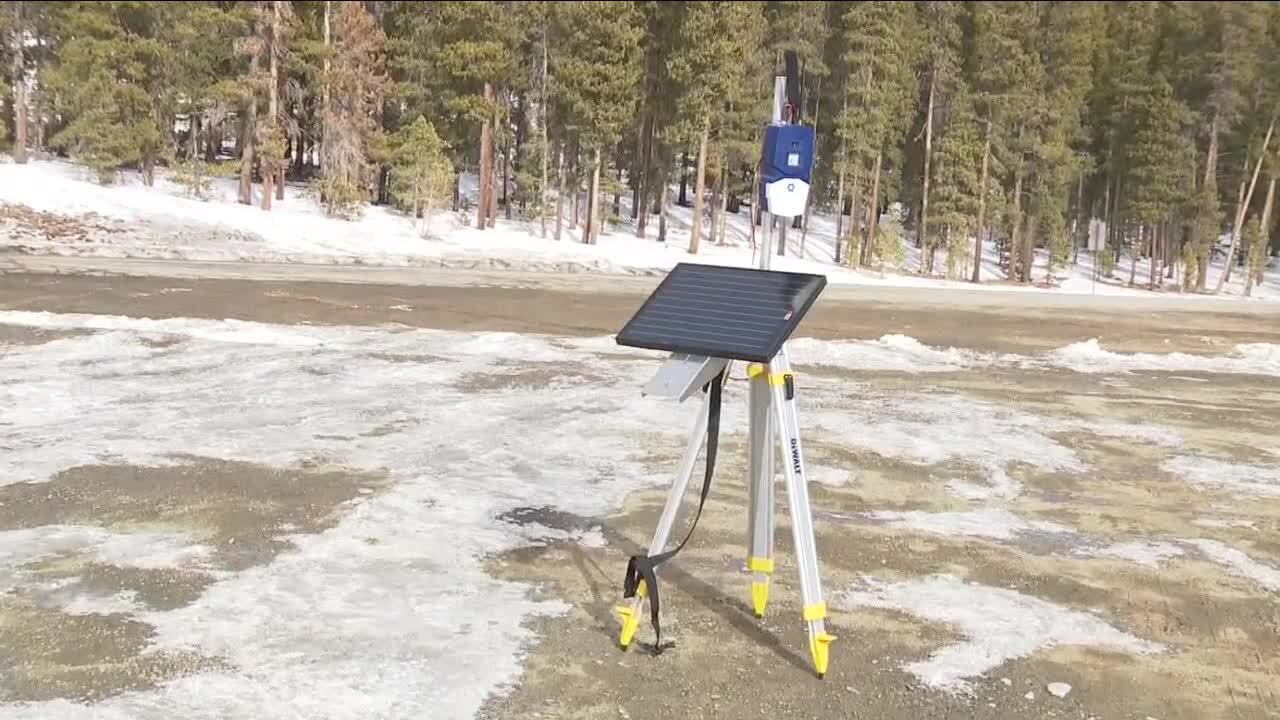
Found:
[550,3,644,243]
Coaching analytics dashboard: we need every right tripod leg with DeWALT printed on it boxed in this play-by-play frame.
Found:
[769,347,836,678]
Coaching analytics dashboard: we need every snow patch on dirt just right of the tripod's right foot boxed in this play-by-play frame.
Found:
[837,575,1165,693]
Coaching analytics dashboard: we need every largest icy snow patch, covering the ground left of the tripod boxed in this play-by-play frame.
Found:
[0,313,721,720]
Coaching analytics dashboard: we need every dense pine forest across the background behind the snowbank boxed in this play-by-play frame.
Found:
[0,0,1280,293]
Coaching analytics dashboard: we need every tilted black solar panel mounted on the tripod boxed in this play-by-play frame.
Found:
[617,263,827,363]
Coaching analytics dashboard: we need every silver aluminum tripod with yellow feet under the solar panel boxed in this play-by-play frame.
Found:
[616,346,835,678]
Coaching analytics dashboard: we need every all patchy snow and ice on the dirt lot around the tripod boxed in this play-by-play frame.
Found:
[0,311,1280,720]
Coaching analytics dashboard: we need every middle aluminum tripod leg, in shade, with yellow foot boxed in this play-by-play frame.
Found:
[746,364,774,618]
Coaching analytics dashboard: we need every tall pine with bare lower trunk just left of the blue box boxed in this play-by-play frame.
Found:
[667,1,765,254]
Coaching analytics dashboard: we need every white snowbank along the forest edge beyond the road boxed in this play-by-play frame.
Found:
[0,159,1280,299]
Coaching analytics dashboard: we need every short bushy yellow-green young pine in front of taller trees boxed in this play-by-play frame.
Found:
[389,115,453,237]
